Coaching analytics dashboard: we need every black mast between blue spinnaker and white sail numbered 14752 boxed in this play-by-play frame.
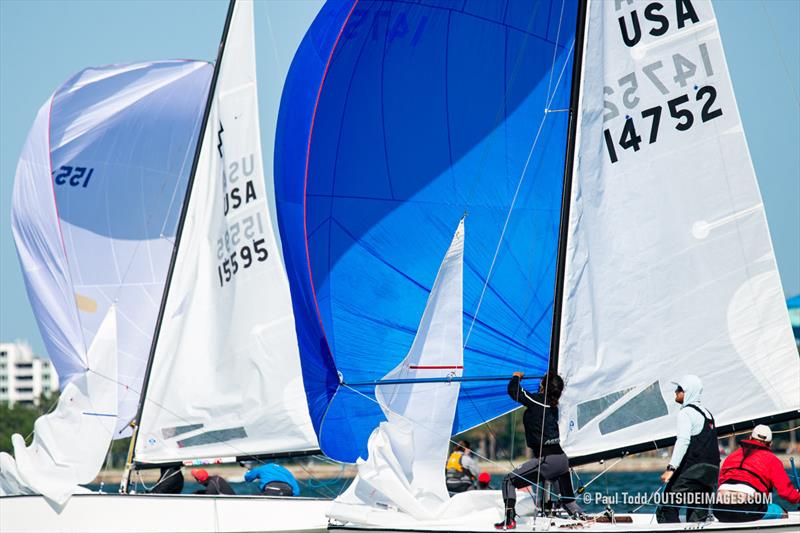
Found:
[548,0,589,373]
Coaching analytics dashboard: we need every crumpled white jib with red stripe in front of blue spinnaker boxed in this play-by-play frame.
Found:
[328,221,464,522]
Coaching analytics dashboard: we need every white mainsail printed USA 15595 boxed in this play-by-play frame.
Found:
[136,1,318,462]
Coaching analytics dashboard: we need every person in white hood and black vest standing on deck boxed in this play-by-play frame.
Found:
[656,375,719,523]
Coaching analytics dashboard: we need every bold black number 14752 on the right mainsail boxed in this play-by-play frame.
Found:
[603,85,722,163]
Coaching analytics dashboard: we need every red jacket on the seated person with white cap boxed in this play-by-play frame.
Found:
[719,439,800,503]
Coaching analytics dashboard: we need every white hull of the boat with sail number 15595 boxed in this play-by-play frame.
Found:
[0,494,331,533]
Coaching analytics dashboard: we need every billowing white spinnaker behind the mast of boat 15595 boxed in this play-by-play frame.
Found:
[11,61,211,437]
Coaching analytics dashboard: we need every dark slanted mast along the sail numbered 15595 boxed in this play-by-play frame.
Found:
[119,0,236,493]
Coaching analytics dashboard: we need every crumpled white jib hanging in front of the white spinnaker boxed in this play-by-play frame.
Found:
[0,306,117,506]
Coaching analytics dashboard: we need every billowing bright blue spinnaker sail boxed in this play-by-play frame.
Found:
[275,0,577,462]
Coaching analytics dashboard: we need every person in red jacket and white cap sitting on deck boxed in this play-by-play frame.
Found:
[714,425,800,522]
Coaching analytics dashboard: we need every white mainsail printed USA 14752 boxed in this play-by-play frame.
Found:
[559,0,800,457]
